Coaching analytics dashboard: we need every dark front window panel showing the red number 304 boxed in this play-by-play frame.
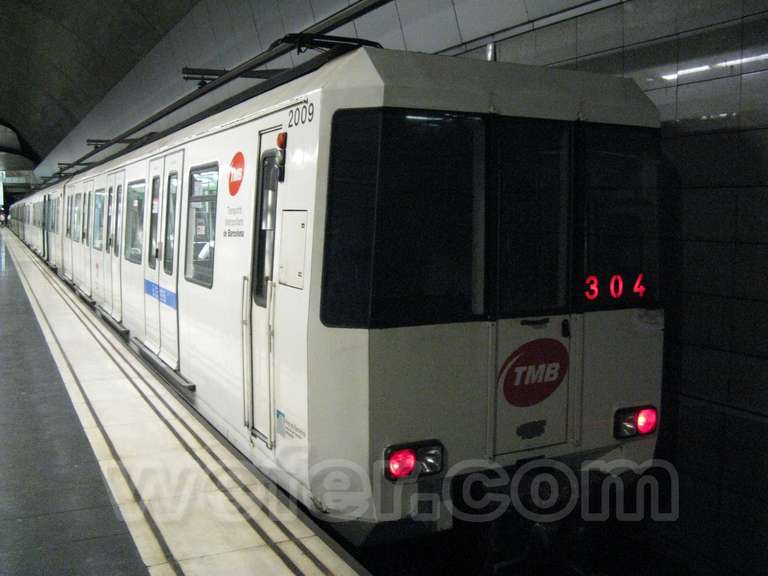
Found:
[574,123,660,310]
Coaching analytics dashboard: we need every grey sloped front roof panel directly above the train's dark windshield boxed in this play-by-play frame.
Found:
[331,48,659,127]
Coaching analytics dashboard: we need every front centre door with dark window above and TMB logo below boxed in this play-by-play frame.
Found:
[491,119,581,455]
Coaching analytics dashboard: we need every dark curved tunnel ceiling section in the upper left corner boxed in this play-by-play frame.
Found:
[0,0,198,158]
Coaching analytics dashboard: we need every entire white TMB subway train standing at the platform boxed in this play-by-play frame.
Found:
[11,46,664,541]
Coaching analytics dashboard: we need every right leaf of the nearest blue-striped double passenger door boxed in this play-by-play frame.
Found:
[158,150,184,370]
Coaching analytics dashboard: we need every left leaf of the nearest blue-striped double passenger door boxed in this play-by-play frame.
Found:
[144,158,163,354]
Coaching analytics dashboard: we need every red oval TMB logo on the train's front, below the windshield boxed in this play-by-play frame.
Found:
[499,338,569,408]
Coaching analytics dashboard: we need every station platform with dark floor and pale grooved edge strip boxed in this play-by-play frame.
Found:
[0,230,366,576]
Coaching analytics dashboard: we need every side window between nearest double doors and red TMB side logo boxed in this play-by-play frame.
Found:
[184,164,219,288]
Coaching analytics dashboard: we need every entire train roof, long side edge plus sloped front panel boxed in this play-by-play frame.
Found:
[19,46,659,205]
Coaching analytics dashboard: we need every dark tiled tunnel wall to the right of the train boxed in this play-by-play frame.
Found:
[466,0,768,574]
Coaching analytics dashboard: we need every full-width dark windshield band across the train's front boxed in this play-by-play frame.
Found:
[321,109,658,328]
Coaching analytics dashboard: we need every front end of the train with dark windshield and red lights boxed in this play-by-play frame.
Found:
[309,49,664,544]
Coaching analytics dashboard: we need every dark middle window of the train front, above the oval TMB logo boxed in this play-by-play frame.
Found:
[496,118,571,318]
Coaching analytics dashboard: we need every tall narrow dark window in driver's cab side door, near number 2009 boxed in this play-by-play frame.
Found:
[253,150,280,306]
